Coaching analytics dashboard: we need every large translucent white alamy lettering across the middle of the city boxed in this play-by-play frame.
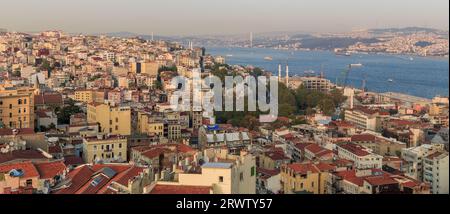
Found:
[170,69,278,123]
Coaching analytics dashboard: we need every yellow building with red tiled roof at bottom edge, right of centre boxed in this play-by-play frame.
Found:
[281,163,334,194]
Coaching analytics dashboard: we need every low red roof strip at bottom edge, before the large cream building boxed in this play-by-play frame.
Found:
[149,184,212,194]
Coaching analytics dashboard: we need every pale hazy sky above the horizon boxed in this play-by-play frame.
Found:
[0,0,449,35]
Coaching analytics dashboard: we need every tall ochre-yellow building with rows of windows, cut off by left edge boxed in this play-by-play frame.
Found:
[0,86,34,129]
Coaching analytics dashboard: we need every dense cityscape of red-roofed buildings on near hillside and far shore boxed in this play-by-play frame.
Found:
[0,30,449,194]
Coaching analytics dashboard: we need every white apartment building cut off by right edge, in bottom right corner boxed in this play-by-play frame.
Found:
[423,152,449,194]
